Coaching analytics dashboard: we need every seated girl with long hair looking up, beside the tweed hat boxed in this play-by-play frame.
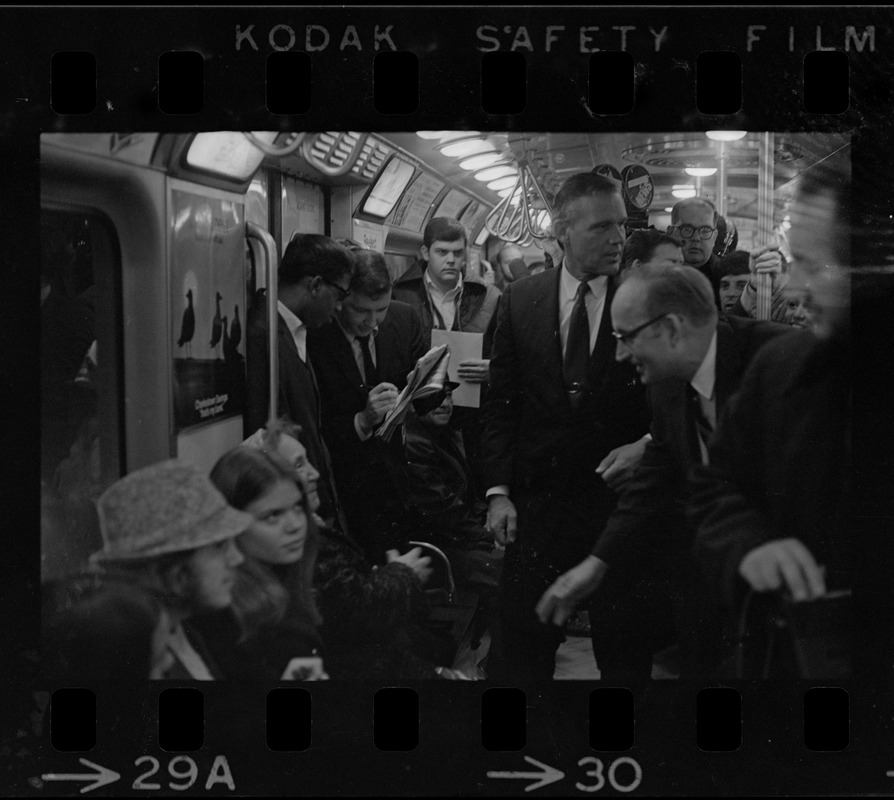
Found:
[201,446,326,680]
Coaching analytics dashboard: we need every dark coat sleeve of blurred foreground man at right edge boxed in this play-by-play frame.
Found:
[688,358,777,607]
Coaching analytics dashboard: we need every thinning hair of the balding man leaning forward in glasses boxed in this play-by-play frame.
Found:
[630,266,717,328]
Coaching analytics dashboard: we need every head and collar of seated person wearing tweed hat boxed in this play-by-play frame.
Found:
[91,461,254,680]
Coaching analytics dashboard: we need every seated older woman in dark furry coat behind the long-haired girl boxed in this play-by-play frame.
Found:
[246,421,466,681]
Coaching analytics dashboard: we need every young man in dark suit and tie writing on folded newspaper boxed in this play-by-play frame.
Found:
[308,250,428,563]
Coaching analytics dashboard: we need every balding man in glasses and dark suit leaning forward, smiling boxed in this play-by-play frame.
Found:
[538,266,800,681]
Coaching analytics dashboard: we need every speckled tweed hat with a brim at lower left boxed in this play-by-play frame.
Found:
[90,461,254,562]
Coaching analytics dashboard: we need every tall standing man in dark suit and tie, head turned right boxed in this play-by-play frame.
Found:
[482,173,648,684]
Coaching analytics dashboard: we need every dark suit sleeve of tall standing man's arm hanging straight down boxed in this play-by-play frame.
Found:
[481,286,521,488]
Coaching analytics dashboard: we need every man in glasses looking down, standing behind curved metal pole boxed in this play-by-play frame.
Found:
[245,233,354,521]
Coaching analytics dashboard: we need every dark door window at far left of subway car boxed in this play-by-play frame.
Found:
[40,210,121,580]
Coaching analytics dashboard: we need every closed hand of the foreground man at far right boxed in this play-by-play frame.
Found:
[739,539,826,600]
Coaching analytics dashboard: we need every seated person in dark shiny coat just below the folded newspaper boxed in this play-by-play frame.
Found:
[404,382,502,587]
